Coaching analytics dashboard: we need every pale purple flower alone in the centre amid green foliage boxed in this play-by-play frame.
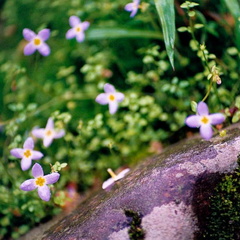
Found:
[95,83,124,114]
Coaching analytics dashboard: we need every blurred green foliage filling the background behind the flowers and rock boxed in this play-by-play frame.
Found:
[0,0,240,239]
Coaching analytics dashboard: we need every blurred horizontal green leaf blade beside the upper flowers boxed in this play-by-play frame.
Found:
[86,28,163,40]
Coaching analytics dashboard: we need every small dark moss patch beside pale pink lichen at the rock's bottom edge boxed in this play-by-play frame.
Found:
[125,210,145,240]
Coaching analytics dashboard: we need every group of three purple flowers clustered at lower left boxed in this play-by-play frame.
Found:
[10,118,65,201]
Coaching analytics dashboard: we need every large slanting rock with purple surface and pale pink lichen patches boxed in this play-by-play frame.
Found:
[23,125,240,240]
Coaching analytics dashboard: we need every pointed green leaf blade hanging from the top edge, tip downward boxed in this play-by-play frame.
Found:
[154,0,176,69]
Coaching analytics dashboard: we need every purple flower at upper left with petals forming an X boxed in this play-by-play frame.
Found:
[23,28,50,56]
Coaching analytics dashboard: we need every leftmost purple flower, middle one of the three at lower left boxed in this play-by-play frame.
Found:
[10,137,43,171]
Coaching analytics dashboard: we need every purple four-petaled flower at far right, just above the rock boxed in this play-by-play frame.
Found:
[185,102,225,140]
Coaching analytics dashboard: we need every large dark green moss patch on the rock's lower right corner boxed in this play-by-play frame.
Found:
[201,158,240,240]
